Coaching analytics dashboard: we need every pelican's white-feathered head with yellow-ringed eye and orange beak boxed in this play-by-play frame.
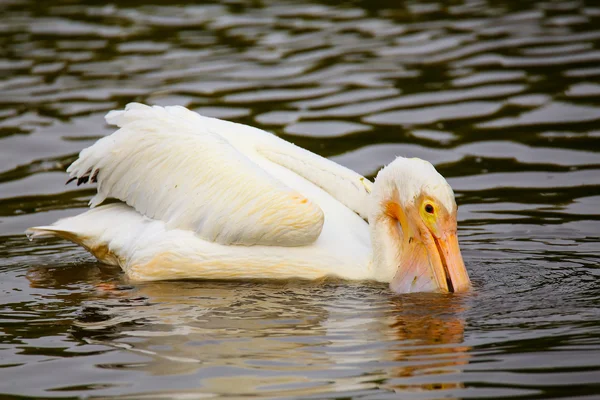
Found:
[369,157,470,293]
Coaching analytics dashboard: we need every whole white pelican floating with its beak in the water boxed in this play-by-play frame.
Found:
[27,103,470,293]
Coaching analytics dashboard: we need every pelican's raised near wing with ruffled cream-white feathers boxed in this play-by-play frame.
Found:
[67,103,324,246]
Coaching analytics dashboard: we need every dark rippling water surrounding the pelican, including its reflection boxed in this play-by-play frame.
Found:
[0,0,600,399]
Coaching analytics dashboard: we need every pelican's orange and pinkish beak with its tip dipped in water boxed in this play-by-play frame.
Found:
[390,214,470,293]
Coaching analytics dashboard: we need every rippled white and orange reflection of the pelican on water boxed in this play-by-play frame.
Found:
[30,267,469,396]
